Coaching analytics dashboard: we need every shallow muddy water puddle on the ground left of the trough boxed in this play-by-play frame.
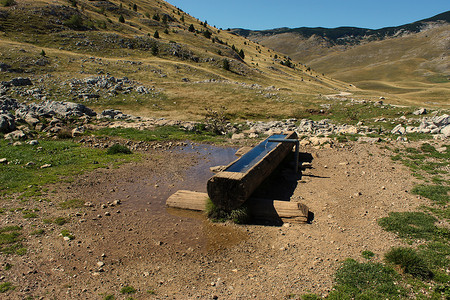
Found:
[118,144,246,251]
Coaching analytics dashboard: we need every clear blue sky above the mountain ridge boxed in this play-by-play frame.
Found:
[168,0,450,30]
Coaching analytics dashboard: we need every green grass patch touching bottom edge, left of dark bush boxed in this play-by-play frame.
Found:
[327,259,406,299]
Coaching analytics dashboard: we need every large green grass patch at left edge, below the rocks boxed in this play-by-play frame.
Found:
[0,141,134,197]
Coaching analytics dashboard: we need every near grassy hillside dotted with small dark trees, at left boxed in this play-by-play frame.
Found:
[0,0,366,119]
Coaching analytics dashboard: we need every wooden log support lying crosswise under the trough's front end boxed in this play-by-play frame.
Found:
[166,190,309,223]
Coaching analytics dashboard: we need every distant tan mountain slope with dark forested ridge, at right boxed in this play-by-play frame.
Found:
[234,12,450,104]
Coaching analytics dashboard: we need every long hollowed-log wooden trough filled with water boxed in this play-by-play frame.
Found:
[207,132,297,210]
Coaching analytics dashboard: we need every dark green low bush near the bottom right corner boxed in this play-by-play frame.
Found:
[385,247,433,279]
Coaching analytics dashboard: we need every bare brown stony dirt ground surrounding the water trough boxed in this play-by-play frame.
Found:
[0,142,426,299]
